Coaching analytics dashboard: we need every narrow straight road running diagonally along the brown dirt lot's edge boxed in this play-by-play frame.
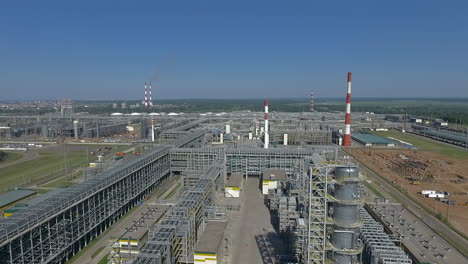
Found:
[360,164,468,258]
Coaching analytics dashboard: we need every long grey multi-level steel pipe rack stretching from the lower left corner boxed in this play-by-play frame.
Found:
[0,131,204,264]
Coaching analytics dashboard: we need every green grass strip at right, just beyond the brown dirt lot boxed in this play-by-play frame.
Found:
[372,131,468,158]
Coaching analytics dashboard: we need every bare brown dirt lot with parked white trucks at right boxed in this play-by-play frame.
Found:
[349,148,468,234]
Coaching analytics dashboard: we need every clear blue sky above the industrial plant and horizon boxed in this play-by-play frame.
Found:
[0,0,468,100]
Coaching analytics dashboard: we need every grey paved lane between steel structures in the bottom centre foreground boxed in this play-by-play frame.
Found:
[231,177,284,264]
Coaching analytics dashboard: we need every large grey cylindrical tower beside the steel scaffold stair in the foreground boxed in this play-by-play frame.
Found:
[330,166,364,264]
